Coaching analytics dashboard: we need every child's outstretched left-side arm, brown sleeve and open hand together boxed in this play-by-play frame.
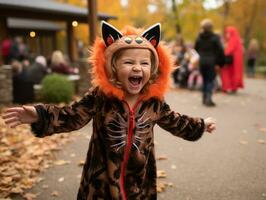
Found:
[3,90,100,137]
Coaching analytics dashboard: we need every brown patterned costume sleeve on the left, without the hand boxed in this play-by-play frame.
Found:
[31,88,99,137]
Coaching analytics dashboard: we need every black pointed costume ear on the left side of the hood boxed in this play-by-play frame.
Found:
[102,21,123,47]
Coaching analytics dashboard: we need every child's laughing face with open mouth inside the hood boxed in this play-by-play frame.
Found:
[115,49,151,96]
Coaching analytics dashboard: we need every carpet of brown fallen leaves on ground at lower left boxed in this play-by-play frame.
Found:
[0,113,76,199]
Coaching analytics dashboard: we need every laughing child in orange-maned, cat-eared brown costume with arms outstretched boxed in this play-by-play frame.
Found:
[3,22,215,200]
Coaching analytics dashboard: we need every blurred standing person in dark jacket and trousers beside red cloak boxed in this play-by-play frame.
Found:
[195,19,225,106]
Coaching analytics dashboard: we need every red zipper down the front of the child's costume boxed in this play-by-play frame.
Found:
[120,99,141,200]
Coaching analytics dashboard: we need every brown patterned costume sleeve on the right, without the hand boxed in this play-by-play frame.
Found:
[157,102,204,141]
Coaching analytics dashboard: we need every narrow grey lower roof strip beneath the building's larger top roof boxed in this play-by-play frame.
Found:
[7,18,63,31]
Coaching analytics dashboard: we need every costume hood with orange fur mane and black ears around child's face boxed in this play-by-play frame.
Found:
[89,22,174,100]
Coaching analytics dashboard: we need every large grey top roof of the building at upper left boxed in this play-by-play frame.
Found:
[0,0,116,22]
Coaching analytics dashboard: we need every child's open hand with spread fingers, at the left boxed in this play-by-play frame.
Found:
[3,106,38,128]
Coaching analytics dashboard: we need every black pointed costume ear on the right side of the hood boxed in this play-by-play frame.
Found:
[142,23,161,48]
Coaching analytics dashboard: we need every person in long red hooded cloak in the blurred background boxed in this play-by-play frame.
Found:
[221,26,244,93]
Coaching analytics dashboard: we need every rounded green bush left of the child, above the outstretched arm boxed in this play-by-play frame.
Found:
[40,74,74,103]
